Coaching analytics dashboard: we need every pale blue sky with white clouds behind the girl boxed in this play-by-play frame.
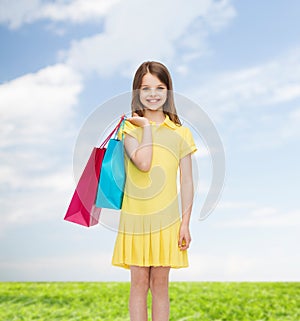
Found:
[0,0,300,281]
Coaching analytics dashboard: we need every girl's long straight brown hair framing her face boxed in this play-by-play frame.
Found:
[131,61,181,125]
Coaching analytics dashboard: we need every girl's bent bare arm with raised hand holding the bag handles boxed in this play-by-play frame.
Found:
[124,114,152,172]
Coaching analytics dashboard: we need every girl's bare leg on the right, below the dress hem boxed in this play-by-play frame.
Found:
[150,266,170,321]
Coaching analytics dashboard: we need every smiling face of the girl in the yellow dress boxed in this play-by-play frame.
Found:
[140,73,168,110]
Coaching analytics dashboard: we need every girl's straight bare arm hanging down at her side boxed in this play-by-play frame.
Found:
[178,154,194,251]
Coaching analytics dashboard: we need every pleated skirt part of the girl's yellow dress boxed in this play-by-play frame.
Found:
[112,210,188,269]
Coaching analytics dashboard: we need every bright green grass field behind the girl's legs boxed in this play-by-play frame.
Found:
[0,282,300,321]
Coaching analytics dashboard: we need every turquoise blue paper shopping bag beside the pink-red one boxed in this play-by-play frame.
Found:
[95,119,126,209]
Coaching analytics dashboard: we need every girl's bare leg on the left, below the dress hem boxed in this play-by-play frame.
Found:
[129,266,150,321]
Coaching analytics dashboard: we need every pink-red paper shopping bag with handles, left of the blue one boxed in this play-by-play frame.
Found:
[64,116,125,227]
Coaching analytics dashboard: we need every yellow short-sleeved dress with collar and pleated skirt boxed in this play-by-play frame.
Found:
[112,115,197,268]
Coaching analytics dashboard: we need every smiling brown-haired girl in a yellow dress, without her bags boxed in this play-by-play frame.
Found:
[112,61,196,321]
